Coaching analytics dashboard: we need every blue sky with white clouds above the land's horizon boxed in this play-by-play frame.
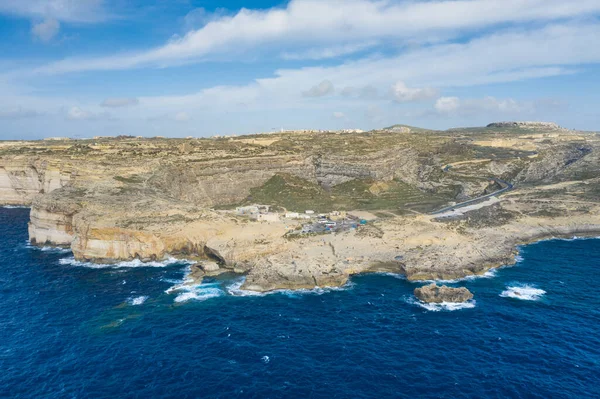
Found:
[0,0,600,140]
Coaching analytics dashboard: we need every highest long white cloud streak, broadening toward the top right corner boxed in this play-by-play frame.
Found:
[23,0,600,74]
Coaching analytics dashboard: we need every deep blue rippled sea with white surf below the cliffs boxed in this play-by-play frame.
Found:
[0,208,600,399]
